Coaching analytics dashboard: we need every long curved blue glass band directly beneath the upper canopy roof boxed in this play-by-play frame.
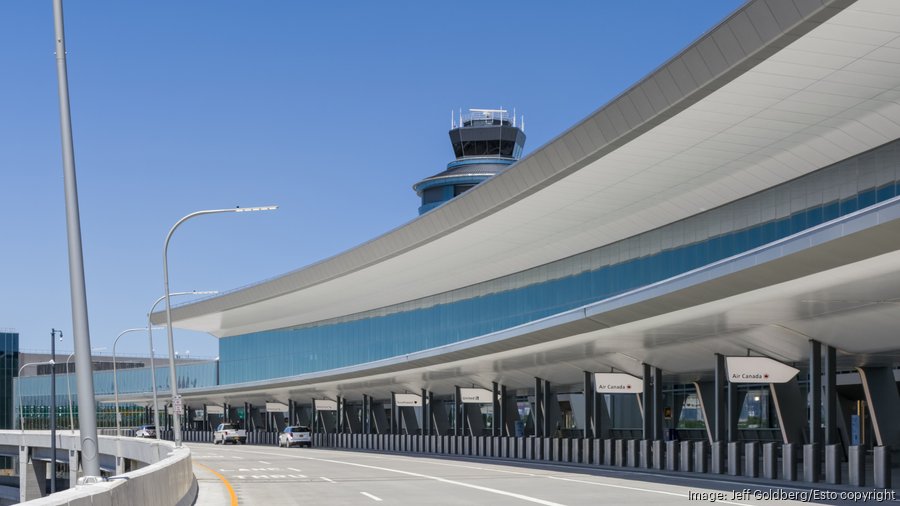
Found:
[220,141,900,384]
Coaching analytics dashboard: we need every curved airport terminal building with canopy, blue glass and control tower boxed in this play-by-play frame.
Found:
[14,0,900,490]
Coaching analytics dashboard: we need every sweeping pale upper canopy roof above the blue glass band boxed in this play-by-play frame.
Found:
[153,0,900,337]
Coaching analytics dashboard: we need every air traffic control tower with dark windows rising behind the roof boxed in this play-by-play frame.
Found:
[413,109,525,214]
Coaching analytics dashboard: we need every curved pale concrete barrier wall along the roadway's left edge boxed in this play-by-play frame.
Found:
[0,431,197,506]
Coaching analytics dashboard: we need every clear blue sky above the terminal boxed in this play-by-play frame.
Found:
[0,0,742,357]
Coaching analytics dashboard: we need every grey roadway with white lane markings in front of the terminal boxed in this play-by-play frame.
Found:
[187,443,896,506]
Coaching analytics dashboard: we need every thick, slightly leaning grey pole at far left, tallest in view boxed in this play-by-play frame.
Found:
[53,0,100,483]
